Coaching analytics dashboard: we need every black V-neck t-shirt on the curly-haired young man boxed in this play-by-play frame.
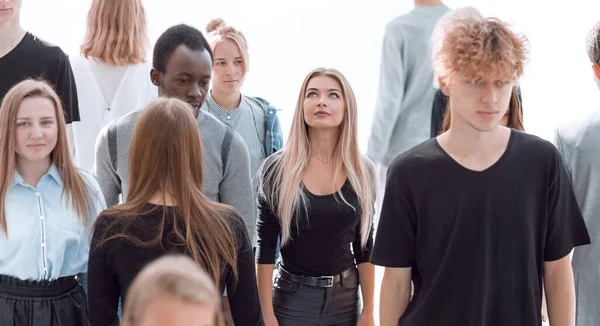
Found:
[371,130,590,326]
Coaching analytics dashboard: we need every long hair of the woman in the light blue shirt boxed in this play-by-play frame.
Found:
[0,79,92,238]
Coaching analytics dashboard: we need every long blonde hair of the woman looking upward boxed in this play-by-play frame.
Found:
[260,68,376,247]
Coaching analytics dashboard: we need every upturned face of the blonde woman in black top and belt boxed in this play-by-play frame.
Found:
[303,76,346,129]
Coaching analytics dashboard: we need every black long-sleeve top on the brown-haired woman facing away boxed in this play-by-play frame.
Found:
[88,204,264,326]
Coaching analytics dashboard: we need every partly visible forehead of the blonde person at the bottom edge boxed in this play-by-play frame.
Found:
[139,296,216,326]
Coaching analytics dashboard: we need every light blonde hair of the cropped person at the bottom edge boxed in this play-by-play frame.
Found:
[123,255,225,326]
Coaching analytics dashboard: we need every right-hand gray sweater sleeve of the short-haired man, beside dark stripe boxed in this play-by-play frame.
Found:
[219,132,258,245]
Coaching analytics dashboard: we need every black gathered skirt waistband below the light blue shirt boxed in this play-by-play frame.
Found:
[0,275,79,298]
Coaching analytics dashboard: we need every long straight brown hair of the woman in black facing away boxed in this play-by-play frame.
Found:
[92,98,238,284]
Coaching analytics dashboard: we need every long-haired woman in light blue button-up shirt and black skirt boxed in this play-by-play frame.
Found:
[0,80,106,326]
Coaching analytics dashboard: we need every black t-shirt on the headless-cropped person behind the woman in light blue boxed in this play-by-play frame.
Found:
[0,33,79,123]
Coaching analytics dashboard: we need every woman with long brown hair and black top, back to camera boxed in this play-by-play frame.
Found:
[89,98,263,326]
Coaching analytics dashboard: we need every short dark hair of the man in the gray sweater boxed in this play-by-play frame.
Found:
[152,24,213,72]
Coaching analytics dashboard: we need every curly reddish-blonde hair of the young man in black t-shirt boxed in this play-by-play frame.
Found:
[432,7,528,83]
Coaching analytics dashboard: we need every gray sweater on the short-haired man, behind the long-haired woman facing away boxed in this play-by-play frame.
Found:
[93,110,257,243]
